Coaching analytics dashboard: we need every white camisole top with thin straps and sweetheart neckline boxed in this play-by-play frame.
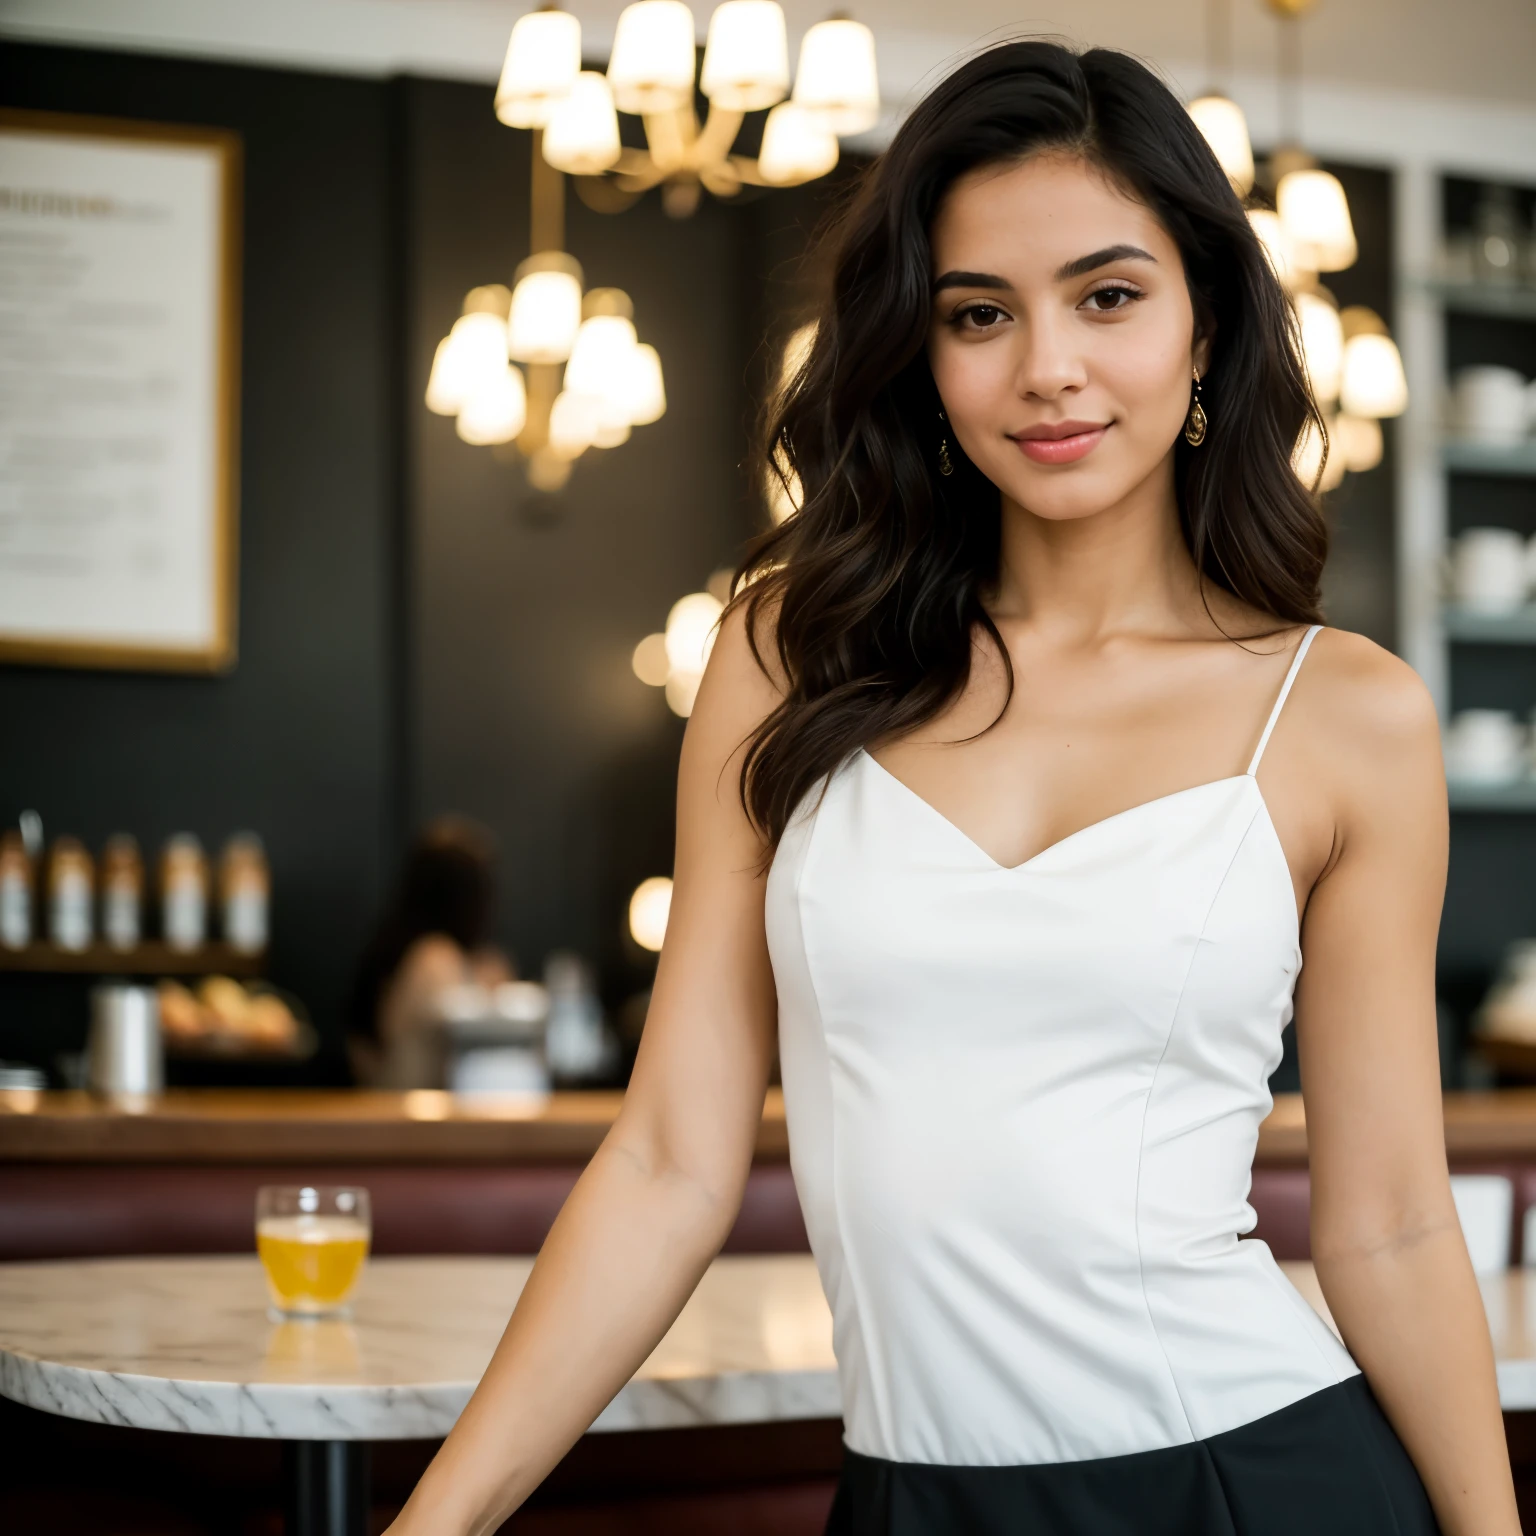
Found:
[766,627,1358,1465]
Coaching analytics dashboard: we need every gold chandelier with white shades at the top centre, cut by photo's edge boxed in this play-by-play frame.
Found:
[496,0,880,218]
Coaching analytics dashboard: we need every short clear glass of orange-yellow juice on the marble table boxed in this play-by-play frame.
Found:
[257,1184,373,1318]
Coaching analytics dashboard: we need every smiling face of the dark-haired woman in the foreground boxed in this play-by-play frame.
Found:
[925,152,1204,521]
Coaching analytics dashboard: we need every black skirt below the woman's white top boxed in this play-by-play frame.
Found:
[826,1376,1439,1536]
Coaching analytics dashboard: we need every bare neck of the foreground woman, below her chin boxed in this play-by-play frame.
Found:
[989,453,1209,644]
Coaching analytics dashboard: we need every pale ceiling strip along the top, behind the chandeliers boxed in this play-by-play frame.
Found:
[0,0,1536,104]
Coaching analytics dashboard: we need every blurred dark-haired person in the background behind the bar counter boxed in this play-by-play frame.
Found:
[347,816,513,1089]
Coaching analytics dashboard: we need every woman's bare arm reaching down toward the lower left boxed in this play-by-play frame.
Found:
[390,613,777,1536]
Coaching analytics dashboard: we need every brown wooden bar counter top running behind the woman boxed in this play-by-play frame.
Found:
[0,1089,1536,1167]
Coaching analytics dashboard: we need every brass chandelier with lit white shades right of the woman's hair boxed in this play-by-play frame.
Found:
[1189,0,1409,490]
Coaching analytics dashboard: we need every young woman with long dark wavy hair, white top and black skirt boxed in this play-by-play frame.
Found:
[395,43,1519,1536]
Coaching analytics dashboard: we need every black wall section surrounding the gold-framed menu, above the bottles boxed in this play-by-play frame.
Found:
[0,45,398,1081]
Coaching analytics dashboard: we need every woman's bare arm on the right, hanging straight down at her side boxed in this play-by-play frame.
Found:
[1296,637,1521,1536]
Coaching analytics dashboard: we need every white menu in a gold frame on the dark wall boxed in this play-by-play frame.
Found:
[0,111,240,671]
